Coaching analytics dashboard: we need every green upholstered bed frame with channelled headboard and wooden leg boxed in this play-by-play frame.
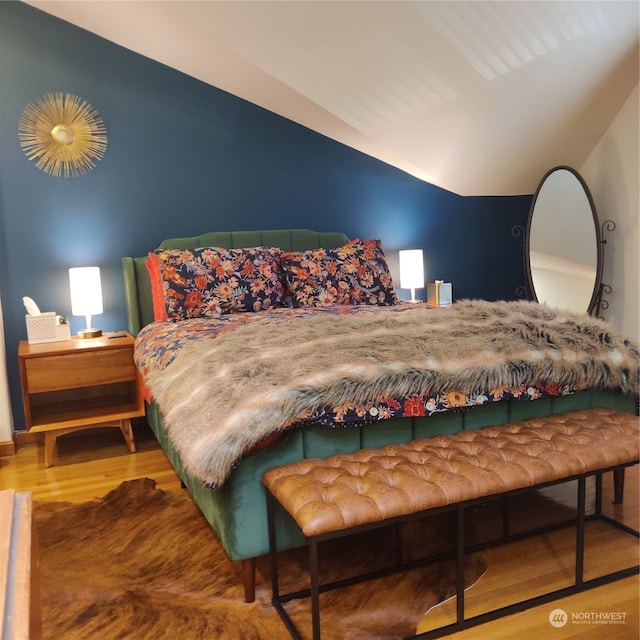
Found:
[122,229,635,601]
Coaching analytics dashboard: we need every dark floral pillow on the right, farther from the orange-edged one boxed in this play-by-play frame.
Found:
[280,240,397,307]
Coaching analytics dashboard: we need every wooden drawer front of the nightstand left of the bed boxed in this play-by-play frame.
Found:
[25,348,136,393]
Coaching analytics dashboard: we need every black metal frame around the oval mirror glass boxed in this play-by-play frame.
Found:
[524,165,604,316]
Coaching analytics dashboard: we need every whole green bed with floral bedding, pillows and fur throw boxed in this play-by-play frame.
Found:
[122,229,638,601]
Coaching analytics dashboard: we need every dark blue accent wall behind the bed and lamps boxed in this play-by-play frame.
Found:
[0,1,531,429]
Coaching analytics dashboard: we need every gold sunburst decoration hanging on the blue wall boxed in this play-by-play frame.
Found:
[18,93,107,178]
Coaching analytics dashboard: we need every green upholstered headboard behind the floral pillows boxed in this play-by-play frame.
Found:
[122,229,349,336]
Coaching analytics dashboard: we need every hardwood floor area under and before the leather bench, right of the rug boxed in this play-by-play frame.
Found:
[418,465,640,640]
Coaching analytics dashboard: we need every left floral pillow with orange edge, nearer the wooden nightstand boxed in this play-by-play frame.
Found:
[157,247,284,320]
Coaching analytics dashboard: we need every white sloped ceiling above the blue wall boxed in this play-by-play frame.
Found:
[27,0,640,195]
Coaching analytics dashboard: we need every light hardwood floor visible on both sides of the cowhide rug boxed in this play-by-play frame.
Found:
[0,424,640,640]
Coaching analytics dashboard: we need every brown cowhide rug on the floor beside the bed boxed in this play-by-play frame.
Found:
[34,479,485,640]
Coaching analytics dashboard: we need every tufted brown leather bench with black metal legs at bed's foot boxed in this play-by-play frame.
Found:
[262,409,640,640]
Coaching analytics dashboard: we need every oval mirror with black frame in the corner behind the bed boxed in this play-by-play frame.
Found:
[524,166,602,313]
